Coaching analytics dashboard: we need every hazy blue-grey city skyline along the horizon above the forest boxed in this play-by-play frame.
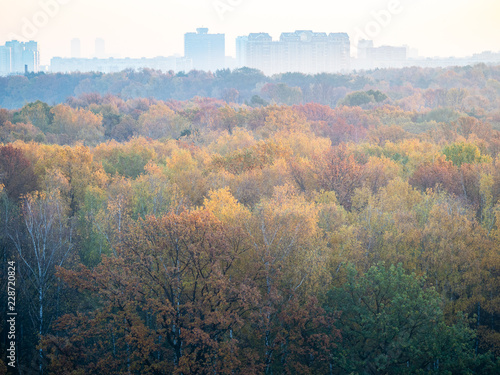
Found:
[0,27,500,76]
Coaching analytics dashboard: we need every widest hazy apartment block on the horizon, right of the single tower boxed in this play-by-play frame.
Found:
[236,30,351,75]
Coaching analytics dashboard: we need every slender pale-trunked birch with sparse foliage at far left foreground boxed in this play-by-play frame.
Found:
[9,189,73,373]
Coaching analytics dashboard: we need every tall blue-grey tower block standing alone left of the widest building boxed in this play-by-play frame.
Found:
[184,28,226,72]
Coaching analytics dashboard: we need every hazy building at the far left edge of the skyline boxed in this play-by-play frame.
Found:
[0,40,40,75]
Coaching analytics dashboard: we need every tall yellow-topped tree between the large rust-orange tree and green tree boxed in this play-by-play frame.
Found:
[245,185,335,373]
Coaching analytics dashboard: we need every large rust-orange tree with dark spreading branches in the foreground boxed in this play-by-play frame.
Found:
[45,211,260,374]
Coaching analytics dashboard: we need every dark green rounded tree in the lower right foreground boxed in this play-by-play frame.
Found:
[327,264,494,374]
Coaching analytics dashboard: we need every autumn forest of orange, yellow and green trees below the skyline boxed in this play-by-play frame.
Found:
[0,64,500,375]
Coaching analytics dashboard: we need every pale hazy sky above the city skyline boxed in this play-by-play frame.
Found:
[0,0,500,64]
